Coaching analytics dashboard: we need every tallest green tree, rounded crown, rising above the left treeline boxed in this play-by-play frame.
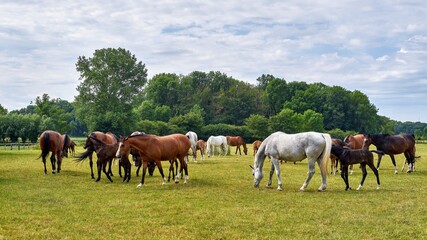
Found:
[75,48,147,135]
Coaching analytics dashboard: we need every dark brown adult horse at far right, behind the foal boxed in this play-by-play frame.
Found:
[364,134,415,174]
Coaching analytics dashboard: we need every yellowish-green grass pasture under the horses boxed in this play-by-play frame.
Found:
[0,144,427,239]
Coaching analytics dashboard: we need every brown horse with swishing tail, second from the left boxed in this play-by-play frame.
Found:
[76,131,118,179]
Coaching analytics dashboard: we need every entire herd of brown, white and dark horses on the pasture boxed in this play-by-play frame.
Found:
[39,130,417,191]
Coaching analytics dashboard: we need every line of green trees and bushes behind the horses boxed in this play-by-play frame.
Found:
[0,48,427,141]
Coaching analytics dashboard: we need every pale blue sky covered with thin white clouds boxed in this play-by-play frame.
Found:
[0,0,427,122]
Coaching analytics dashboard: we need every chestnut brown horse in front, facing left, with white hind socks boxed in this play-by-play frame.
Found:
[116,134,191,187]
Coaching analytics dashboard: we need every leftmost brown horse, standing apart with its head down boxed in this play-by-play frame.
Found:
[39,130,70,174]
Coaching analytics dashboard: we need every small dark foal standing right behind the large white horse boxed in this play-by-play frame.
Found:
[331,145,384,191]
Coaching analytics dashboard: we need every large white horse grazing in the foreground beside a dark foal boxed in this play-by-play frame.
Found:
[252,132,332,191]
